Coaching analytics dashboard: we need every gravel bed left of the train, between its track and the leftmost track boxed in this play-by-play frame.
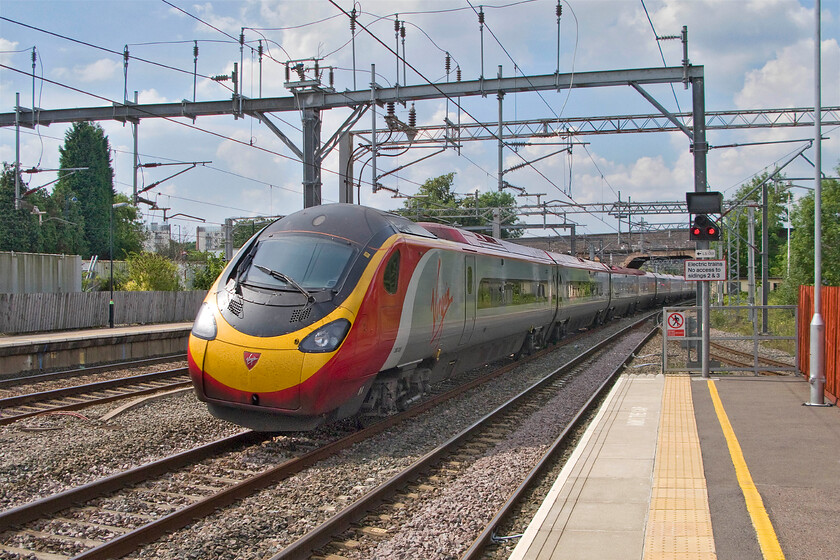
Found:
[0,392,242,509]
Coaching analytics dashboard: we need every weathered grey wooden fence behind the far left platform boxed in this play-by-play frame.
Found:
[0,290,207,334]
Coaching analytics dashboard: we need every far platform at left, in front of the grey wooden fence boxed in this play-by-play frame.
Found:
[0,322,192,376]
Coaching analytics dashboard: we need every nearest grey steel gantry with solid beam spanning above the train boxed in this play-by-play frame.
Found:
[0,65,708,207]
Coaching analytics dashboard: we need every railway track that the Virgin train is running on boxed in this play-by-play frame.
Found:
[0,312,656,559]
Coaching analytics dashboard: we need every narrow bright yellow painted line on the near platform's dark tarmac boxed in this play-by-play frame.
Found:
[708,380,785,560]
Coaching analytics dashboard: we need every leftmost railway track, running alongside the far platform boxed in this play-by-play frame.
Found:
[0,368,190,425]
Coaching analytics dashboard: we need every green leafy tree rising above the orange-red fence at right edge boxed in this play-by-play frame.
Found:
[782,166,840,303]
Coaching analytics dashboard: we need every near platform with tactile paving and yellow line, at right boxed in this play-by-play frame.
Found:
[511,374,840,560]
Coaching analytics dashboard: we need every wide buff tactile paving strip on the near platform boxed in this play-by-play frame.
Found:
[644,376,717,560]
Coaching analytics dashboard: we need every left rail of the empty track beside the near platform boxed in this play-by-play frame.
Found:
[270,312,658,560]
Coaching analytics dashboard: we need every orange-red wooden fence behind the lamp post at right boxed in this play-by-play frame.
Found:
[799,286,840,404]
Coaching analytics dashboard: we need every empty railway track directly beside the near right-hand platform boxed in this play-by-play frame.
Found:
[271,316,656,560]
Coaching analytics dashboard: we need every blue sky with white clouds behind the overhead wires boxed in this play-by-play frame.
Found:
[0,0,840,240]
